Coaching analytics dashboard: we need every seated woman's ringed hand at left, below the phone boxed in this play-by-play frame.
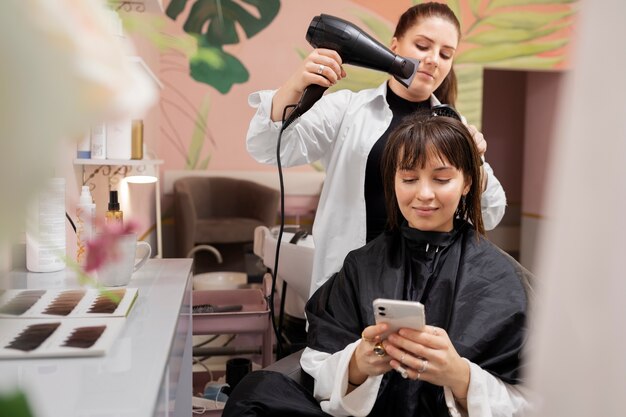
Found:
[348,323,391,385]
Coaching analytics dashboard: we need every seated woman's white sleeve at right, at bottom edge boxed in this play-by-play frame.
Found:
[444,361,531,417]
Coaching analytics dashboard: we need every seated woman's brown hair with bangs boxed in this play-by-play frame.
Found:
[382,112,485,234]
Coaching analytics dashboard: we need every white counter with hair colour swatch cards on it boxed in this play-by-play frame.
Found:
[0,259,192,417]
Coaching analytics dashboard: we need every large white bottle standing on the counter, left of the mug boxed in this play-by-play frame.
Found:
[26,178,66,272]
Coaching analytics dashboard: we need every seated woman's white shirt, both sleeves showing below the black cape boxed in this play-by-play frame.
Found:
[300,339,531,417]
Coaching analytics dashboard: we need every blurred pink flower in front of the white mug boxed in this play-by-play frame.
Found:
[85,221,137,273]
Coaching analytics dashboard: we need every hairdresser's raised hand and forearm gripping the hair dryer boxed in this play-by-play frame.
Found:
[271,48,346,122]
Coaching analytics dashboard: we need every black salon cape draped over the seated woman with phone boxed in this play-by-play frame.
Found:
[306,222,527,417]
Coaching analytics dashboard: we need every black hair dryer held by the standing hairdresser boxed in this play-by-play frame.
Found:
[283,14,419,128]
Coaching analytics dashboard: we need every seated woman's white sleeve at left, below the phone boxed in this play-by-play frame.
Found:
[300,339,382,417]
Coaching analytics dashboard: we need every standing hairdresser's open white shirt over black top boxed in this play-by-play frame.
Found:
[246,82,506,294]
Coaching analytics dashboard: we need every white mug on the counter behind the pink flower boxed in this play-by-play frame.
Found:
[96,233,152,287]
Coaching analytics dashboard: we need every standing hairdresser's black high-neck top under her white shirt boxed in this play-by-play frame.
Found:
[365,84,430,242]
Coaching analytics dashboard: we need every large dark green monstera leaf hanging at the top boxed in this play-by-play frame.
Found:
[165,0,280,94]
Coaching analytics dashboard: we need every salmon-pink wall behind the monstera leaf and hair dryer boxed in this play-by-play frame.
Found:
[158,0,392,170]
